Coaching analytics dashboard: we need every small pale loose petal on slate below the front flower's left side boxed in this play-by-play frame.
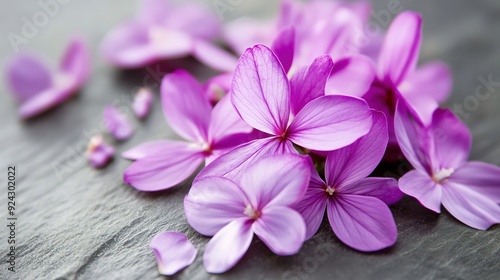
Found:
[149,231,198,275]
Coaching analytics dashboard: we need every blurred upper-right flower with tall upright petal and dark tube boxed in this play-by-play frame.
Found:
[363,12,452,160]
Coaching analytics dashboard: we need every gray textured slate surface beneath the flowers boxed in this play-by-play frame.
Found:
[0,0,500,279]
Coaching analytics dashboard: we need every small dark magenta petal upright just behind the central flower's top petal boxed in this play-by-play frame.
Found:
[271,27,295,72]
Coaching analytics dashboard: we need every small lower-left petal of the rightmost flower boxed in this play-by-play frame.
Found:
[399,170,443,213]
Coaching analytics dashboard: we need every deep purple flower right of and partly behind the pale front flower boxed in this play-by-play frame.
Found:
[294,111,402,251]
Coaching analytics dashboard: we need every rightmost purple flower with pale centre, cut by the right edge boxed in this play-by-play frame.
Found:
[395,101,500,230]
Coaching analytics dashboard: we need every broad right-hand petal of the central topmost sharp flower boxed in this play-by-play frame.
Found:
[288,95,372,151]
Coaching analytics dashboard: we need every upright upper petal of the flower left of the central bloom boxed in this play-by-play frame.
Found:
[161,70,212,142]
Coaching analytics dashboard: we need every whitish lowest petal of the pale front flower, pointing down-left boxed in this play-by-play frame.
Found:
[203,218,253,273]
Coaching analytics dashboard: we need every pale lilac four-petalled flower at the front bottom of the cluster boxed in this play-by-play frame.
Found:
[184,154,310,273]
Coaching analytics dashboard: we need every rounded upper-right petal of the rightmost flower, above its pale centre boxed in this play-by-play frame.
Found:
[431,109,472,171]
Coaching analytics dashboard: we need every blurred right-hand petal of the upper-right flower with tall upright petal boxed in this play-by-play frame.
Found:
[398,61,453,102]
